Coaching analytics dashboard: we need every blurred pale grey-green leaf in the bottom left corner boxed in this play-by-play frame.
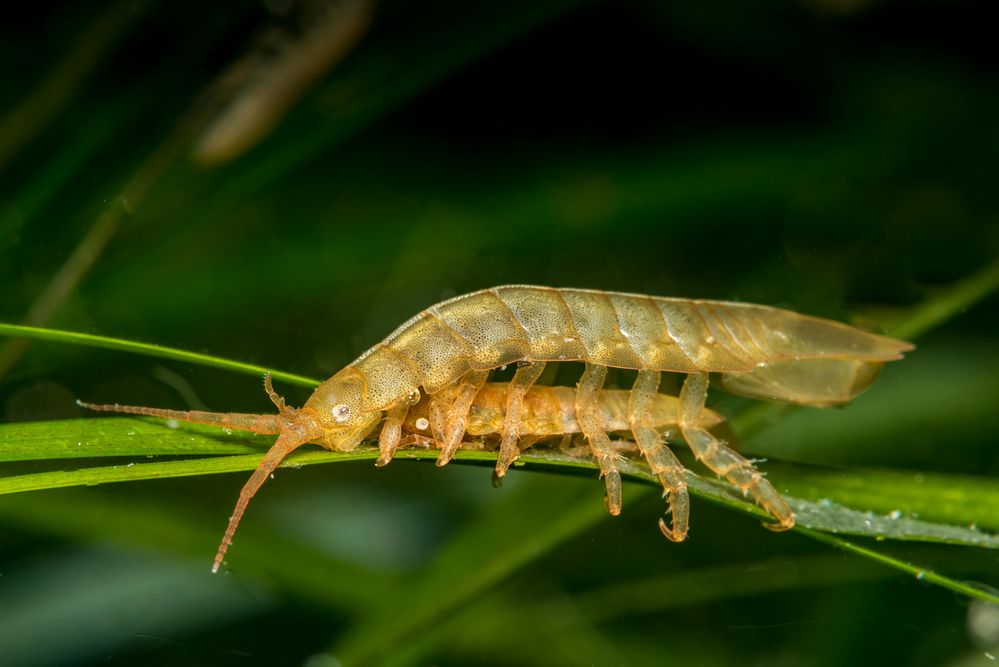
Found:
[0,549,266,666]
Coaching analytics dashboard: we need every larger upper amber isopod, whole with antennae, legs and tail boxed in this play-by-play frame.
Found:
[78,285,912,570]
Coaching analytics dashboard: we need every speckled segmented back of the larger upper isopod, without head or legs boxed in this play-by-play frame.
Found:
[342,285,909,410]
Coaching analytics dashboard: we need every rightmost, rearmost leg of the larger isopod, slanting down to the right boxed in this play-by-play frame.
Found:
[678,373,794,530]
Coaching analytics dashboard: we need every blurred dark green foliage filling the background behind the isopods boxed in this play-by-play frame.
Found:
[0,0,999,667]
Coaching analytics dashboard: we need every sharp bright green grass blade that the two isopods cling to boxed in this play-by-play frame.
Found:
[0,418,999,548]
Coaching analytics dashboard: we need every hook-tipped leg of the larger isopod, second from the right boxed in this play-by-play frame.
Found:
[628,371,690,542]
